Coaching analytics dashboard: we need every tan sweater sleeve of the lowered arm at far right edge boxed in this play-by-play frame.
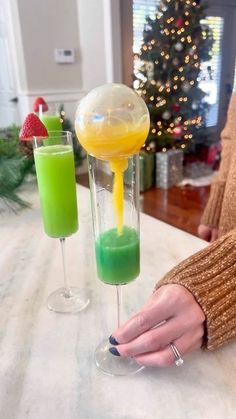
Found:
[201,94,236,227]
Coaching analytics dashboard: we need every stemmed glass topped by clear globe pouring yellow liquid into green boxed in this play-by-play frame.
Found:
[75,83,150,375]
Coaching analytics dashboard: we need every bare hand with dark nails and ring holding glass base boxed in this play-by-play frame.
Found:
[110,284,205,367]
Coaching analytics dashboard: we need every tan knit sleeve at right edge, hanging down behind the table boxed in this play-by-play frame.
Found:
[201,93,236,236]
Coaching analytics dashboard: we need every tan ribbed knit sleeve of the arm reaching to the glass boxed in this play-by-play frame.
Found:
[156,229,236,350]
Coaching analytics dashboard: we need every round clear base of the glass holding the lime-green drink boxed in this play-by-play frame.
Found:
[47,287,89,313]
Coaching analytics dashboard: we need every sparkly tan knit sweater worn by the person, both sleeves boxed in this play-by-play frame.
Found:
[157,94,236,350]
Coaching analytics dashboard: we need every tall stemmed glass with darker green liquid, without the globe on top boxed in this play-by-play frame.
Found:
[88,154,142,375]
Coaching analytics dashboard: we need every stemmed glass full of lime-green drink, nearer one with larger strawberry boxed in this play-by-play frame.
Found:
[34,131,89,313]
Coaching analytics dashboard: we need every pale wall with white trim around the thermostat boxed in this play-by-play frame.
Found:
[10,0,121,120]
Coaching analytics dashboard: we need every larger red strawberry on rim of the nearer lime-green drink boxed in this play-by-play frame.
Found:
[19,113,48,141]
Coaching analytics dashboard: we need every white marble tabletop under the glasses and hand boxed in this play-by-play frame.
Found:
[0,185,236,419]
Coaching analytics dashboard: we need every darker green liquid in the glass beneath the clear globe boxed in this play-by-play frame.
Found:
[95,226,140,285]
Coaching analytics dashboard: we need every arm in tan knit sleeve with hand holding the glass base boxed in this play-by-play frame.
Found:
[110,229,236,366]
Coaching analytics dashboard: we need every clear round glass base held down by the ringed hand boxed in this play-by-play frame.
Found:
[95,339,144,375]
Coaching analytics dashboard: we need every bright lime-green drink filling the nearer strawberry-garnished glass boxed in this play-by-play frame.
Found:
[34,144,78,238]
